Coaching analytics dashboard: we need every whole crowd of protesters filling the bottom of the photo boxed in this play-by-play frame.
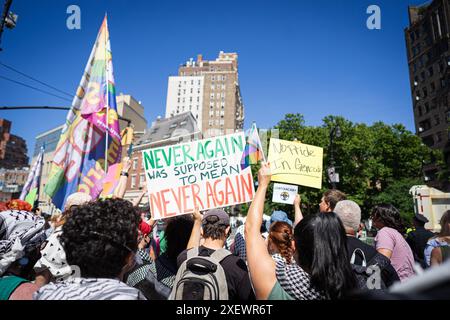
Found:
[0,160,450,301]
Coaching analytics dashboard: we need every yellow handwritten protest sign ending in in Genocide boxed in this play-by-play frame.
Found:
[268,139,323,189]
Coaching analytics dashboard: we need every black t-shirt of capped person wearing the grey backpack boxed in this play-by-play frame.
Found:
[177,246,255,300]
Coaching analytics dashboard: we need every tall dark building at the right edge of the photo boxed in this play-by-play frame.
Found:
[405,0,450,185]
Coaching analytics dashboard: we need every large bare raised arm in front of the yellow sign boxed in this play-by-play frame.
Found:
[245,163,277,300]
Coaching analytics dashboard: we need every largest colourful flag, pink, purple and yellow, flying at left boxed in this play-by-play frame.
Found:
[45,17,122,209]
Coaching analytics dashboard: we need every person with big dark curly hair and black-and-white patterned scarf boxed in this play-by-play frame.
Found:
[33,199,145,300]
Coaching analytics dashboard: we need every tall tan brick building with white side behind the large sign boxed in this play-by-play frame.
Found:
[166,51,244,137]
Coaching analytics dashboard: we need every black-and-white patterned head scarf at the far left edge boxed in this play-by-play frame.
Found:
[0,210,46,275]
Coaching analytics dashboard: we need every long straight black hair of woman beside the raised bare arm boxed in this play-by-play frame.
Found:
[294,212,357,299]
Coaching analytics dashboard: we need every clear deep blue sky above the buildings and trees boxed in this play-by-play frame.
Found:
[0,0,424,160]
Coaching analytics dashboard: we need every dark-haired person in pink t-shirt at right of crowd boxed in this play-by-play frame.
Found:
[371,204,414,281]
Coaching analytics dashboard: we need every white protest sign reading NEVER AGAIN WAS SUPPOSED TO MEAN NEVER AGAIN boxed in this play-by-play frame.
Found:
[142,132,255,219]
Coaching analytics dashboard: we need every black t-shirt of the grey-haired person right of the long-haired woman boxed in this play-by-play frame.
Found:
[347,236,400,287]
